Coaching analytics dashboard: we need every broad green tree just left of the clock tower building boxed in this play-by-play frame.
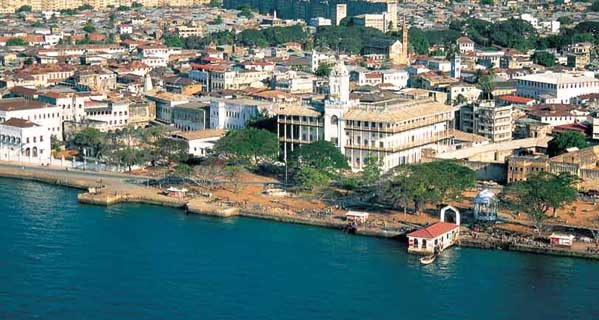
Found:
[213,128,279,167]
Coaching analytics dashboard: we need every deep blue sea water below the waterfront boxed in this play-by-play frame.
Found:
[0,179,599,320]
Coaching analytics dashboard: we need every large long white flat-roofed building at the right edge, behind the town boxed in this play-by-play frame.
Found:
[516,72,599,103]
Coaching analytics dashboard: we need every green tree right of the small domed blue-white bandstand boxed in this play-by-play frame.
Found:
[505,172,577,232]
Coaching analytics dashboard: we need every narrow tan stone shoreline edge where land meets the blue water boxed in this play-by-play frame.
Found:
[0,167,599,260]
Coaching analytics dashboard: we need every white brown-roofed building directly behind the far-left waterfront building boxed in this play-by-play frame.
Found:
[0,98,63,140]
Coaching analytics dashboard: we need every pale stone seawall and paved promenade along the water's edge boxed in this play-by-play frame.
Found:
[0,163,599,259]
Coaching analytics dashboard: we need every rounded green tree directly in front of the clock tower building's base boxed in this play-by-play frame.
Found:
[289,140,349,174]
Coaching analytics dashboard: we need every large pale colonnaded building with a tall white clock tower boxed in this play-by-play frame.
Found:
[277,58,454,171]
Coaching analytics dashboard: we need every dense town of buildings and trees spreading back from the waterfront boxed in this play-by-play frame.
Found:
[0,0,599,249]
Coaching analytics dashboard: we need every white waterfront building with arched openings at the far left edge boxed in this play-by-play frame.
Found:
[0,118,52,163]
